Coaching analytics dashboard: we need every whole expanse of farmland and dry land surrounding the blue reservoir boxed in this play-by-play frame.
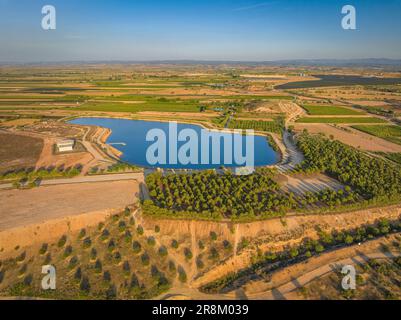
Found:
[0,63,401,299]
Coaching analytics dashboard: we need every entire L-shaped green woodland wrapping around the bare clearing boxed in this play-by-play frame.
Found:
[144,133,401,220]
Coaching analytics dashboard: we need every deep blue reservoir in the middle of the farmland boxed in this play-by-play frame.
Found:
[69,118,280,170]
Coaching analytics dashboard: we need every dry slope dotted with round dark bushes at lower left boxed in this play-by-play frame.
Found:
[0,209,233,299]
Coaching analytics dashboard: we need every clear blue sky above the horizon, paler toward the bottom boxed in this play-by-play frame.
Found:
[0,0,401,62]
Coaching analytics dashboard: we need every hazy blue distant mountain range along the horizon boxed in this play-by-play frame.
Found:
[0,58,401,68]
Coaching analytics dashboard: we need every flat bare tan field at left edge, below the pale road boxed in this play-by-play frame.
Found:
[0,181,139,231]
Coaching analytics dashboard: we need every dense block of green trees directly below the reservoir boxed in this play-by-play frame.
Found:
[146,170,296,218]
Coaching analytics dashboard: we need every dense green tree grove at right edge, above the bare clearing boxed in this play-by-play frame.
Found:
[298,133,401,201]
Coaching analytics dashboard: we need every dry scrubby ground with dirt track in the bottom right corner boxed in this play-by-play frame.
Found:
[244,234,401,300]
